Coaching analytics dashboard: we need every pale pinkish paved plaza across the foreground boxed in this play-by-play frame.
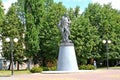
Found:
[0,70,120,80]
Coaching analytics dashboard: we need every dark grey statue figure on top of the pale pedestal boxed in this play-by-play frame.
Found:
[58,14,71,43]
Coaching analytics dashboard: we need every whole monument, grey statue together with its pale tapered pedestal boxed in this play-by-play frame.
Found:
[57,14,78,72]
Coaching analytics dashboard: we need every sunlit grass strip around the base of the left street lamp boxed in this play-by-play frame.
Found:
[0,70,30,76]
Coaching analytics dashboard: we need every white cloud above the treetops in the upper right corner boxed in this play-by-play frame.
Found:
[92,0,120,10]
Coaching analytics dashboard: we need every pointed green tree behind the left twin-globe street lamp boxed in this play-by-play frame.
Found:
[2,3,24,69]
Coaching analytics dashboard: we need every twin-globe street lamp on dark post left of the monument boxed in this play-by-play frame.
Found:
[6,37,18,75]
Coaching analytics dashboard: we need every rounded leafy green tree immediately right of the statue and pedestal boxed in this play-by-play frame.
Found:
[71,16,99,64]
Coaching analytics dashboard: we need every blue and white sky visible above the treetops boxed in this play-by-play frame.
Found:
[2,0,120,12]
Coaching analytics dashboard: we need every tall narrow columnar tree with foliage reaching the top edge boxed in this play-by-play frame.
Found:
[24,0,44,63]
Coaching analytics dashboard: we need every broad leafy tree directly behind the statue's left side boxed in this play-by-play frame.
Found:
[39,0,66,66]
